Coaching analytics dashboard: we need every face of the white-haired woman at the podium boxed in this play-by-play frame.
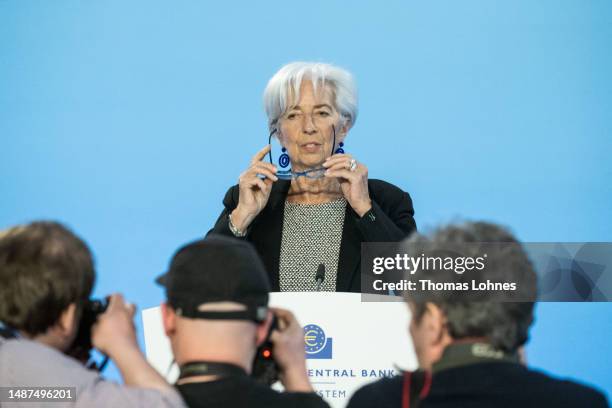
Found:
[279,80,348,171]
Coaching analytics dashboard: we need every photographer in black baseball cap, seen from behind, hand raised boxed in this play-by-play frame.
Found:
[157,235,327,408]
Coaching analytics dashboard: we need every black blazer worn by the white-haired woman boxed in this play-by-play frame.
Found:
[208,180,416,292]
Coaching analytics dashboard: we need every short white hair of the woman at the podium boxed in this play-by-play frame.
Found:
[264,62,357,131]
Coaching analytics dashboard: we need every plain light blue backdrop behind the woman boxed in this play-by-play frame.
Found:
[0,0,612,400]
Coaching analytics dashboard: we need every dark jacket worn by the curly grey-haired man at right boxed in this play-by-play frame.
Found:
[347,356,608,408]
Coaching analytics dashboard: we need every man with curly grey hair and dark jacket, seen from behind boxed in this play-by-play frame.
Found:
[348,222,608,408]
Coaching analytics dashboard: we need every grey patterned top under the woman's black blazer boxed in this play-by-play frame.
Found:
[279,197,346,292]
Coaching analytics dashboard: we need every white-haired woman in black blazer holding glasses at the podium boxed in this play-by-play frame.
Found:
[210,62,416,292]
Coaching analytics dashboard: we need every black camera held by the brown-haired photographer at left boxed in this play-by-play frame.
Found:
[67,298,108,371]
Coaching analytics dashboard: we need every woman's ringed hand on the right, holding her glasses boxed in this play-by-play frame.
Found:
[323,153,372,217]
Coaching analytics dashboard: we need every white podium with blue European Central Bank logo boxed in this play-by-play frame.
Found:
[142,292,417,407]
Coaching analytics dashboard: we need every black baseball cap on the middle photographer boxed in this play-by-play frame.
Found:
[155,235,270,322]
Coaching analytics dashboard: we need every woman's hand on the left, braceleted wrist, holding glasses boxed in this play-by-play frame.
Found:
[230,145,278,232]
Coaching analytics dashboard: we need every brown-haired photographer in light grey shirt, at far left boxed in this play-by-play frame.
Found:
[0,222,184,407]
